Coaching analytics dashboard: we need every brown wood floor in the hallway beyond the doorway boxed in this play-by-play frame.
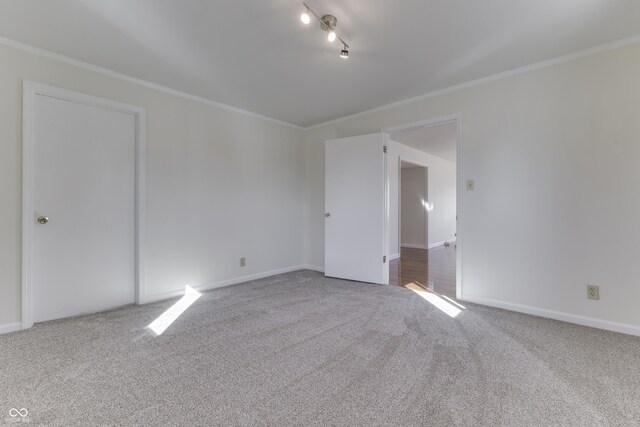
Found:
[389,244,456,298]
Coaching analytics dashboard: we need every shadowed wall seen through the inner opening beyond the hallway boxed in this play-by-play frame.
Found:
[400,167,428,249]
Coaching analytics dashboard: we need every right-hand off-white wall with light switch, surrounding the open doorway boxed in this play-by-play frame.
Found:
[305,44,640,333]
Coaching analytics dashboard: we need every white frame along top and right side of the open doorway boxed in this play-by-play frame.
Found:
[382,113,466,300]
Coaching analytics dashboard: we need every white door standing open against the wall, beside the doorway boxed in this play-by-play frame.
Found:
[324,133,389,284]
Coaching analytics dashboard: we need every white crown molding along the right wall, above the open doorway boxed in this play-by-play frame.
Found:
[305,35,640,130]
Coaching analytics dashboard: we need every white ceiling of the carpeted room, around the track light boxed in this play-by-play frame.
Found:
[0,0,640,126]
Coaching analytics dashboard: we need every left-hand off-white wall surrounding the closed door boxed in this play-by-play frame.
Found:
[0,45,306,331]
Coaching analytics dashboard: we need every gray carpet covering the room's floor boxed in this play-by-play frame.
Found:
[0,271,640,426]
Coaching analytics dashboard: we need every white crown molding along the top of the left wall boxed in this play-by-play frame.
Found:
[0,37,304,130]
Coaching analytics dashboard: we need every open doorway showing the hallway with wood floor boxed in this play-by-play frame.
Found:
[386,118,460,298]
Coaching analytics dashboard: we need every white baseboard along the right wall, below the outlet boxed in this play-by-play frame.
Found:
[459,295,640,336]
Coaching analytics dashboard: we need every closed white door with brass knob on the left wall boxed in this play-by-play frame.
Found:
[31,94,136,322]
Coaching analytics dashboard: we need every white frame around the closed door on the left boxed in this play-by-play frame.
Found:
[22,80,147,329]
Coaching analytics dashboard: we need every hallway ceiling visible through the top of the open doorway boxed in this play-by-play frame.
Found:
[390,122,457,163]
